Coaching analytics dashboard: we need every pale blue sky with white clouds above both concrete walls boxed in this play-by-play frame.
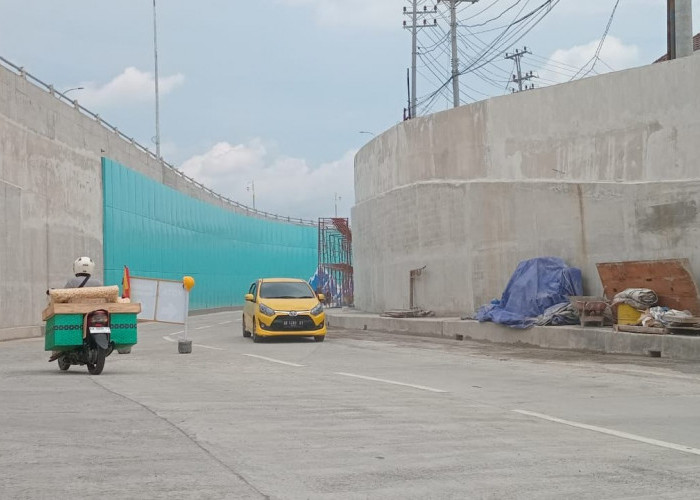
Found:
[0,0,700,219]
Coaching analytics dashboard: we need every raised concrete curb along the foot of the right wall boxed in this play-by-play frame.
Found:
[326,309,700,361]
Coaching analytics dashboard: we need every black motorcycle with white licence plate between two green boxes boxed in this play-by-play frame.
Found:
[49,309,113,375]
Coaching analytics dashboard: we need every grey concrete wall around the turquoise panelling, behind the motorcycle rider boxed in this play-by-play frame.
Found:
[0,65,308,340]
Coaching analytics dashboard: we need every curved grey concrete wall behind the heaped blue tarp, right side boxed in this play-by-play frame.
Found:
[352,56,700,314]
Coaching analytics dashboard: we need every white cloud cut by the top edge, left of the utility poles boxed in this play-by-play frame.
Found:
[278,0,408,30]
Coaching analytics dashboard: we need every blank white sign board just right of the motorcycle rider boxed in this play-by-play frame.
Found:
[130,277,187,323]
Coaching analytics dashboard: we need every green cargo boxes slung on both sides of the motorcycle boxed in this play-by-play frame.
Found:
[44,313,137,351]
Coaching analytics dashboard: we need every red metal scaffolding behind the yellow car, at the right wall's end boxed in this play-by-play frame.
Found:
[316,217,354,307]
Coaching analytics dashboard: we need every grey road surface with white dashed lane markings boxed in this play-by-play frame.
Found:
[0,312,700,499]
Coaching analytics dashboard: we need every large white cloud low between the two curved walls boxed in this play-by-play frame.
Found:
[180,140,355,220]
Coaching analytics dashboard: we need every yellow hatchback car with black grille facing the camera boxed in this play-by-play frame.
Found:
[242,278,327,342]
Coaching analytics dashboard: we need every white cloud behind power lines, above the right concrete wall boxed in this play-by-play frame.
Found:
[538,36,644,83]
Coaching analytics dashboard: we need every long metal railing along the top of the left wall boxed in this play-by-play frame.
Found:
[0,56,317,226]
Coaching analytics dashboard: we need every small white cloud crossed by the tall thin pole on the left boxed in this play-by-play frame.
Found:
[75,67,185,108]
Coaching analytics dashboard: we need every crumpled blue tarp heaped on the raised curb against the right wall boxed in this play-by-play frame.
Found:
[476,257,583,328]
